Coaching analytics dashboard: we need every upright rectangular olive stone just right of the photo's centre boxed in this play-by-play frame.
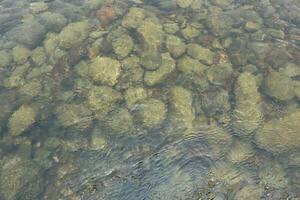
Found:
[169,86,195,134]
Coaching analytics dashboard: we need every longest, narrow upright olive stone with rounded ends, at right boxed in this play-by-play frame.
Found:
[232,72,263,136]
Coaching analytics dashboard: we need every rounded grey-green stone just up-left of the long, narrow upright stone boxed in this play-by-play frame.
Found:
[206,63,233,86]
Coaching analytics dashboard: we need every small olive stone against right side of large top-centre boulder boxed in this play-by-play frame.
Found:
[166,35,186,58]
